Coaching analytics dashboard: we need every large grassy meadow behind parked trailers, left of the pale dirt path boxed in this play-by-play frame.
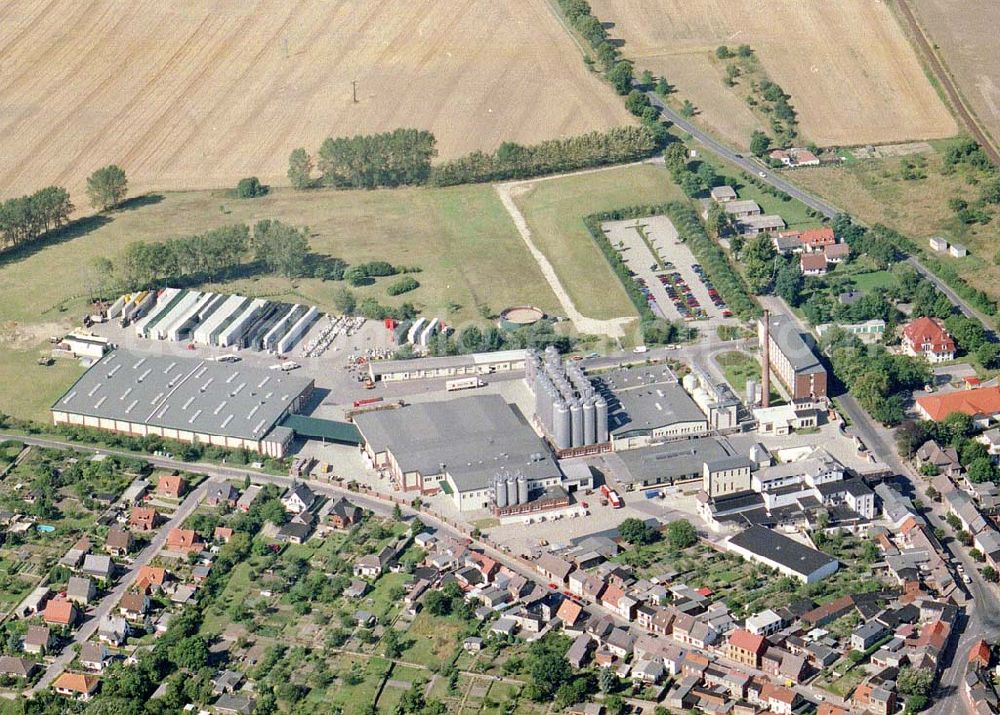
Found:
[0,185,568,420]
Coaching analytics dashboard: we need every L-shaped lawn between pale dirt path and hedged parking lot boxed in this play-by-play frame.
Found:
[514,164,684,319]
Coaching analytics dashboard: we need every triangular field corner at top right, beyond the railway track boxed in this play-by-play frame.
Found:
[909,0,1000,148]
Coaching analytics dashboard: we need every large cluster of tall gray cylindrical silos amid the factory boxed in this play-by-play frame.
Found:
[524,346,608,450]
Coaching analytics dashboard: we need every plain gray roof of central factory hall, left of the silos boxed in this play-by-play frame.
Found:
[354,395,559,491]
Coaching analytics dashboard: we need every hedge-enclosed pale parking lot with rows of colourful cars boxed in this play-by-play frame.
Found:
[603,216,732,332]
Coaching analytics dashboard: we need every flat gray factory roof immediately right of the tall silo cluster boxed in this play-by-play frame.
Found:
[601,370,707,437]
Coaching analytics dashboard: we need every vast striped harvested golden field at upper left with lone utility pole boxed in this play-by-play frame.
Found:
[0,0,630,204]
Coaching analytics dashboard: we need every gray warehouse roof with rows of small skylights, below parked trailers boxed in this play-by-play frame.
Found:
[52,349,312,440]
